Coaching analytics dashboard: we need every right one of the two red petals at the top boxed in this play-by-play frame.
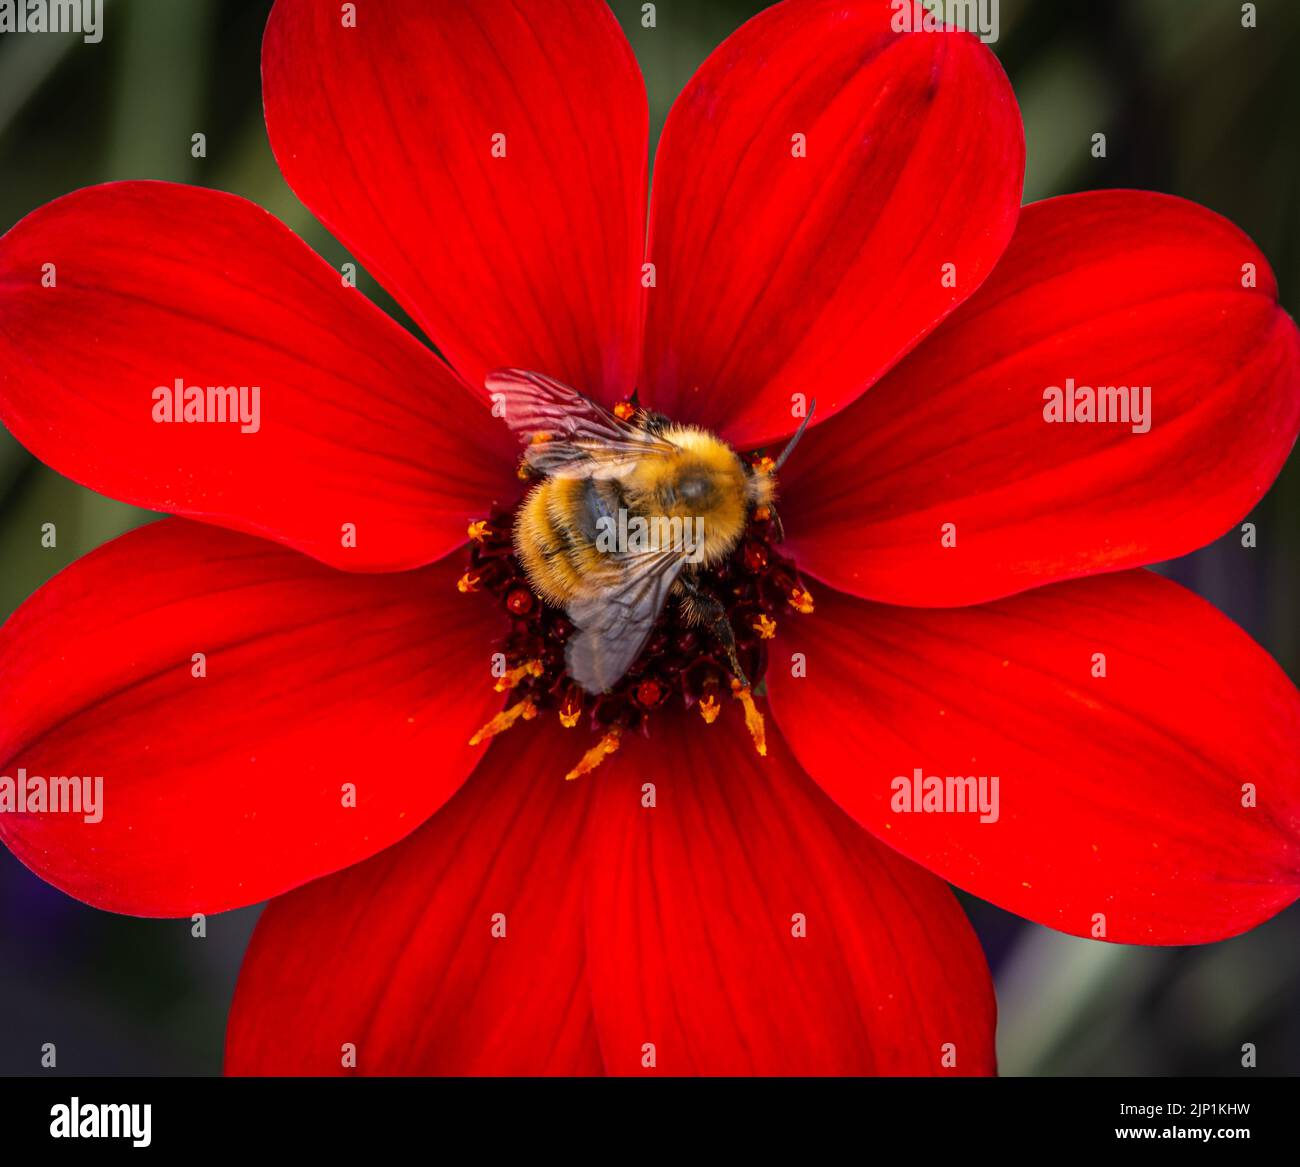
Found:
[641,0,1024,444]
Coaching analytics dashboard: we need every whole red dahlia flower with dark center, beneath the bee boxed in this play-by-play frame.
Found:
[0,0,1300,1073]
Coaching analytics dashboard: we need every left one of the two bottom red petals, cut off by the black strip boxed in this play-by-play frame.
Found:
[226,719,602,1075]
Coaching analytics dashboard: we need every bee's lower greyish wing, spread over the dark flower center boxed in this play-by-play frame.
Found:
[564,550,686,693]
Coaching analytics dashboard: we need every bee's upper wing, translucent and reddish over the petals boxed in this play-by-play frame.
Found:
[486,369,675,478]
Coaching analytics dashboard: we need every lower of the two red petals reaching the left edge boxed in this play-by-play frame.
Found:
[0,520,501,916]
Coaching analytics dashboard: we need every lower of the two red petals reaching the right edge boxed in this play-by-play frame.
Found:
[767,572,1300,943]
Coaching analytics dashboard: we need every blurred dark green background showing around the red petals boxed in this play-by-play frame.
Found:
[0,0,1300,1075]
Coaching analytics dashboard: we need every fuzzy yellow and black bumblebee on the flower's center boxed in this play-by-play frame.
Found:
[486,369,813,694]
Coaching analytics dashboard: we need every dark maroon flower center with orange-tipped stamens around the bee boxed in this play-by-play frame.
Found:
[456,413,813,780]
